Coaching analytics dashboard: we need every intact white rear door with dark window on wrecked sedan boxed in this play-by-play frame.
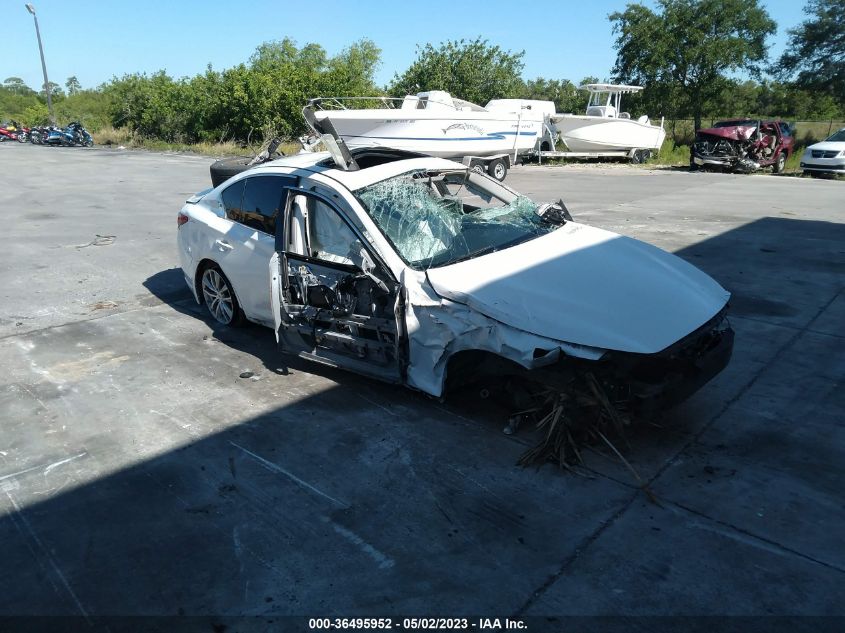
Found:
[213,174,296,325]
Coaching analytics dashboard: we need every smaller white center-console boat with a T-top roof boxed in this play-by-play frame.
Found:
[548,84,666,152]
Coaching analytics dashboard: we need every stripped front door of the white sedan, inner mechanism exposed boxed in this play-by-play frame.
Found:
[270,189,406,382]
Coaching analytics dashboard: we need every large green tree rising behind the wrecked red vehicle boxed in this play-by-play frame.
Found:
[609,0,776,129]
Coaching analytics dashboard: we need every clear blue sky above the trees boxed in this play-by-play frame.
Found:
[0,0,805,88]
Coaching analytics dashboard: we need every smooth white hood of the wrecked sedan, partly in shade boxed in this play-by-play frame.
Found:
[427,222,730,354]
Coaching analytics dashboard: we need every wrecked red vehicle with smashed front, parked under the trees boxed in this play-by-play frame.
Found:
[690,119,795,174]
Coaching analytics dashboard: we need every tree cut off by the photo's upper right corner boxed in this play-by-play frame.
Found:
[778,0,845,105]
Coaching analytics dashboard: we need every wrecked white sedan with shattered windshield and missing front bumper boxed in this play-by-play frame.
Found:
[178,150,733,446]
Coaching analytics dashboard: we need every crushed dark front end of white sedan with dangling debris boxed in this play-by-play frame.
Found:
[506,310,734,468]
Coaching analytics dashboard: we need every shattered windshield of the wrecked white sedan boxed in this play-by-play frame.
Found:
[357,170,560,270]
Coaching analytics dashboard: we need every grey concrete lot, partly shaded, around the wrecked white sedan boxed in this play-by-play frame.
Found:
[0,143,845,616]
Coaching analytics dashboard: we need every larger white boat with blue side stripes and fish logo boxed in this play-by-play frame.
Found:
[311,90,554,158]
